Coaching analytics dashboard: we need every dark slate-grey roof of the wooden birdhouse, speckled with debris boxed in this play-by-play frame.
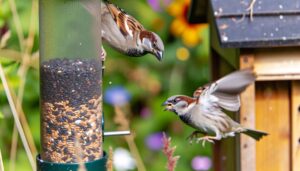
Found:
[191,0,300,48]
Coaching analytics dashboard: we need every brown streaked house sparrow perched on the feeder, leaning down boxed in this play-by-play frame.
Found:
[81,0,164,61]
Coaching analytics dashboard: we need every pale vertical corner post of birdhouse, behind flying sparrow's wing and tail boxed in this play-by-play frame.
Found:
[239,54,256,171]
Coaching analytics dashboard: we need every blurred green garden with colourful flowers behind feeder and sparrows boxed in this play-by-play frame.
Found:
[0,0,212,171]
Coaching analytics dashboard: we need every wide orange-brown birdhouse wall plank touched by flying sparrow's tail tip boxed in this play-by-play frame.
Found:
[254,81,291,171]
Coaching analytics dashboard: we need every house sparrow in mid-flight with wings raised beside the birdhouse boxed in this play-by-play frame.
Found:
[163,69,268,145]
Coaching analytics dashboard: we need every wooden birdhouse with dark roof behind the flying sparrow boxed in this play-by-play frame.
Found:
[189,0,300,171]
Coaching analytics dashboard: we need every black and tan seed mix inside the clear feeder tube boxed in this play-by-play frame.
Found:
[40,59,102,163]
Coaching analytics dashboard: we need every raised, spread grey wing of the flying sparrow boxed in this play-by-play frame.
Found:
[194,69,256,112]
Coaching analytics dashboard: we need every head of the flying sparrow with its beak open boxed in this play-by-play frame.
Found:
[162,95,196,116]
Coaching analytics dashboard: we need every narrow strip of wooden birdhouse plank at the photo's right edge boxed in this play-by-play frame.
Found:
[291,81,300,171]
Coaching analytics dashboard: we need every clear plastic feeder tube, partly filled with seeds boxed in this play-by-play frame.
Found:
[39,0,103,163]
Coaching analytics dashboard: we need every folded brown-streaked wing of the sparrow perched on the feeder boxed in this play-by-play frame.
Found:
[105,2,144,37]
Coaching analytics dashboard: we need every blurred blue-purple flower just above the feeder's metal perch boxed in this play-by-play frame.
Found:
[104,86,131,106]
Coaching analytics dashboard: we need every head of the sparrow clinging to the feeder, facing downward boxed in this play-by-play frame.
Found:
[140,31,164,61]
